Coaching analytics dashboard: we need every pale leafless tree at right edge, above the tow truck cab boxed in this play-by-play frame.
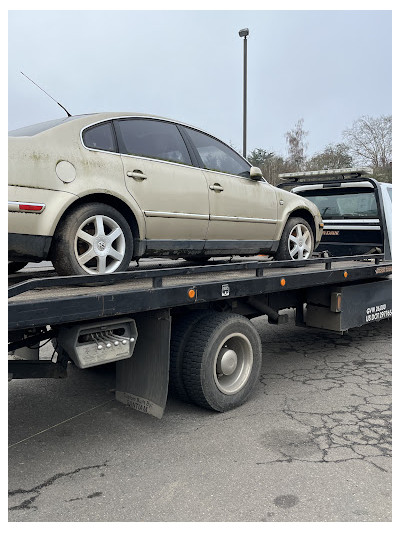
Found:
[343,115,392,169]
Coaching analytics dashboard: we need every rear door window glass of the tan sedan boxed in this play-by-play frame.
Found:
[116,119,192,165]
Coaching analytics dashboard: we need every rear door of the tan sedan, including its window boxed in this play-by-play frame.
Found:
[115,118,209,250]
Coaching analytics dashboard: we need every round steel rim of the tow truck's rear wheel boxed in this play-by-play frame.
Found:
[214,333,253,395]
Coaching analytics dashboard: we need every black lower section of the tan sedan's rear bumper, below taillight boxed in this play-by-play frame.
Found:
[8,233,52,261]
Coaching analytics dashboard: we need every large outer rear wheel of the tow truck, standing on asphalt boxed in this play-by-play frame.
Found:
[183,312,262,412]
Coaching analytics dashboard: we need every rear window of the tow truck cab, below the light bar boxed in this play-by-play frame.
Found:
[298,188,378,220]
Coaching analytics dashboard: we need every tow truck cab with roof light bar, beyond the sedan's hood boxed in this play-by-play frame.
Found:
[278,168,392,259]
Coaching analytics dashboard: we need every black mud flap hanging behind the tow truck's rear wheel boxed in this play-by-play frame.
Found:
[115,309,171,418]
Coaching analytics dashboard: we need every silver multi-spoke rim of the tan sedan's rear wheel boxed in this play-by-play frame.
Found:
[74,215,126,274]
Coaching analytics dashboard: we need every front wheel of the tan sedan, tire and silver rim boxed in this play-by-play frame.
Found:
[275,217,314,261]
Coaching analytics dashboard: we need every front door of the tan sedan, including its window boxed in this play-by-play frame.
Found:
[185,128,277,247]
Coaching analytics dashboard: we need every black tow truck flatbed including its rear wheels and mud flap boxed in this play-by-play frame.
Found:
[8,254,392,417]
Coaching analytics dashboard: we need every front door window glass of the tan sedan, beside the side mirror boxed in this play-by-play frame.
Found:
[185,128,250,177]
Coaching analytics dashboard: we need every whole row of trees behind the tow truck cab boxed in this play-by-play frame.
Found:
[247,115,392,185]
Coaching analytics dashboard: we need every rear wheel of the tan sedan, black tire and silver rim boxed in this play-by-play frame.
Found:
[52,203,133,276]
